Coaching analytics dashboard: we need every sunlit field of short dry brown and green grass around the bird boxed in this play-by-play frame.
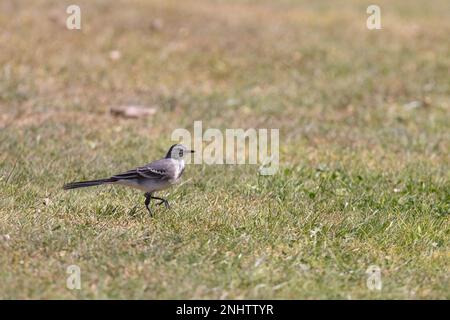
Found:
[0,0,450,299]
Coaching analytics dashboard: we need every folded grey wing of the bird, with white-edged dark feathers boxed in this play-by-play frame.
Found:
[111,159,176,180]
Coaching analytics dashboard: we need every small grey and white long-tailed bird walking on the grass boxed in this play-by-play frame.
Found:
[63,144,194,215]
